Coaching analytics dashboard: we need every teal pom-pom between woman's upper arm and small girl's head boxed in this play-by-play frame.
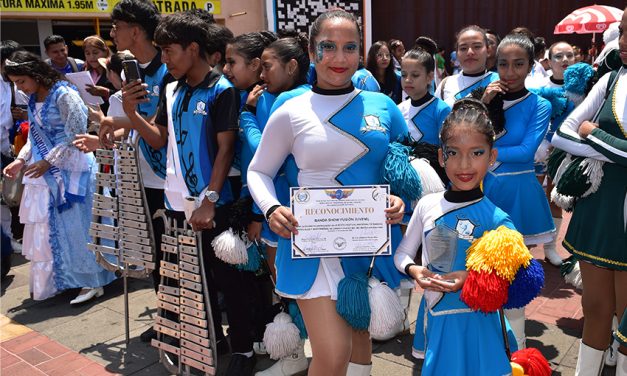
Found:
[382,142,422,201]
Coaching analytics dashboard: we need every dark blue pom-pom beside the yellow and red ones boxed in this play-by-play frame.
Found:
[503,259,544,309]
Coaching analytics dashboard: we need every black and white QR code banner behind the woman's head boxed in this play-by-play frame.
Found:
[266,0,372,55]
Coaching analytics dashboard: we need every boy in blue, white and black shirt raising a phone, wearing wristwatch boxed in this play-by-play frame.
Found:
[123,12,255,375]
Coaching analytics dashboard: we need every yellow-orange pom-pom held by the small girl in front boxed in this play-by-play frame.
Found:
[466,226,533,283]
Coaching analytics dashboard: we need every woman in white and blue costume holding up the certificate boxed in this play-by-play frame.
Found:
[248,10,407,376]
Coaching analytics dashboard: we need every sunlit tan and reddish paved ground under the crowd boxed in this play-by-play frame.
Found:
[0,213,614,376]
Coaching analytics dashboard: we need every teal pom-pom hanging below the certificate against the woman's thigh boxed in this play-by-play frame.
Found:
[335,273,371,330]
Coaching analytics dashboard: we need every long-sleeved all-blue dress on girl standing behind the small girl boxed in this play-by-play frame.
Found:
[483,91,555,244]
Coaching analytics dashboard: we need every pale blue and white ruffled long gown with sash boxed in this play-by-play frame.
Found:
[28,81,115,291]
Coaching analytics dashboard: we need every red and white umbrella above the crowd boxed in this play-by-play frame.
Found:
[553,5,623,35]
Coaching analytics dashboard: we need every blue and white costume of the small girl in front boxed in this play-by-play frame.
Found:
[395,189,516,376]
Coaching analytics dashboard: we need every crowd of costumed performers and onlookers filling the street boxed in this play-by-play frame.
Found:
[0,0,627,376]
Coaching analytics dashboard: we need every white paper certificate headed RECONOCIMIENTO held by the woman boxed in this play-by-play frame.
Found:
[290,185,392,259]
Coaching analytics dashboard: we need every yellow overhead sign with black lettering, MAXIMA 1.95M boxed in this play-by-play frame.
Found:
[0,0,221,14]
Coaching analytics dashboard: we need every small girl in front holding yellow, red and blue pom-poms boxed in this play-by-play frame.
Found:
[394,98,537,375]
